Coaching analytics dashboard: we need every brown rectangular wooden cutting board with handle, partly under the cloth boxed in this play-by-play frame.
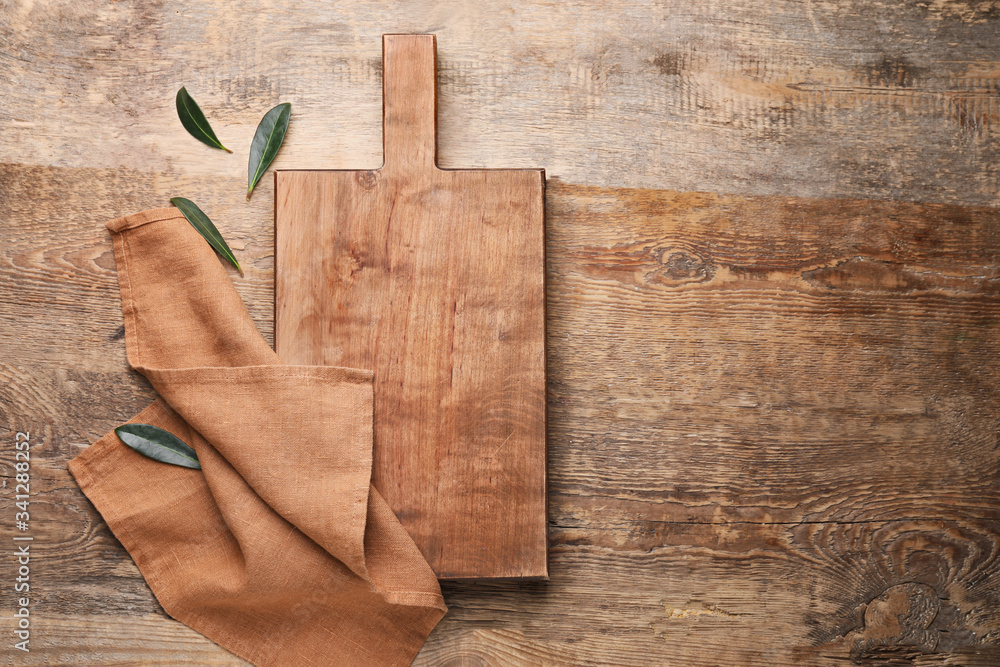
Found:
[275,35,547,579]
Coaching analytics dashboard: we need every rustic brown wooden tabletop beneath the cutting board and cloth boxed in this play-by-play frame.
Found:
[0,0,1000,666]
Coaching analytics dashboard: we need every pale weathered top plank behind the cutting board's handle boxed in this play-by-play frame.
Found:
[0,0,1000,206]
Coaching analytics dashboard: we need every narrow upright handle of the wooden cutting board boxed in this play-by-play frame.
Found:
[382,35,437,170]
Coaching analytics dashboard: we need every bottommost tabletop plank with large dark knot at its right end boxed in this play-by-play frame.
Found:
[4,470,1000,667]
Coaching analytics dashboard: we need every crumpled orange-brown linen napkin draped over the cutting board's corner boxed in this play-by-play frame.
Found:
[69,208,446,667]
